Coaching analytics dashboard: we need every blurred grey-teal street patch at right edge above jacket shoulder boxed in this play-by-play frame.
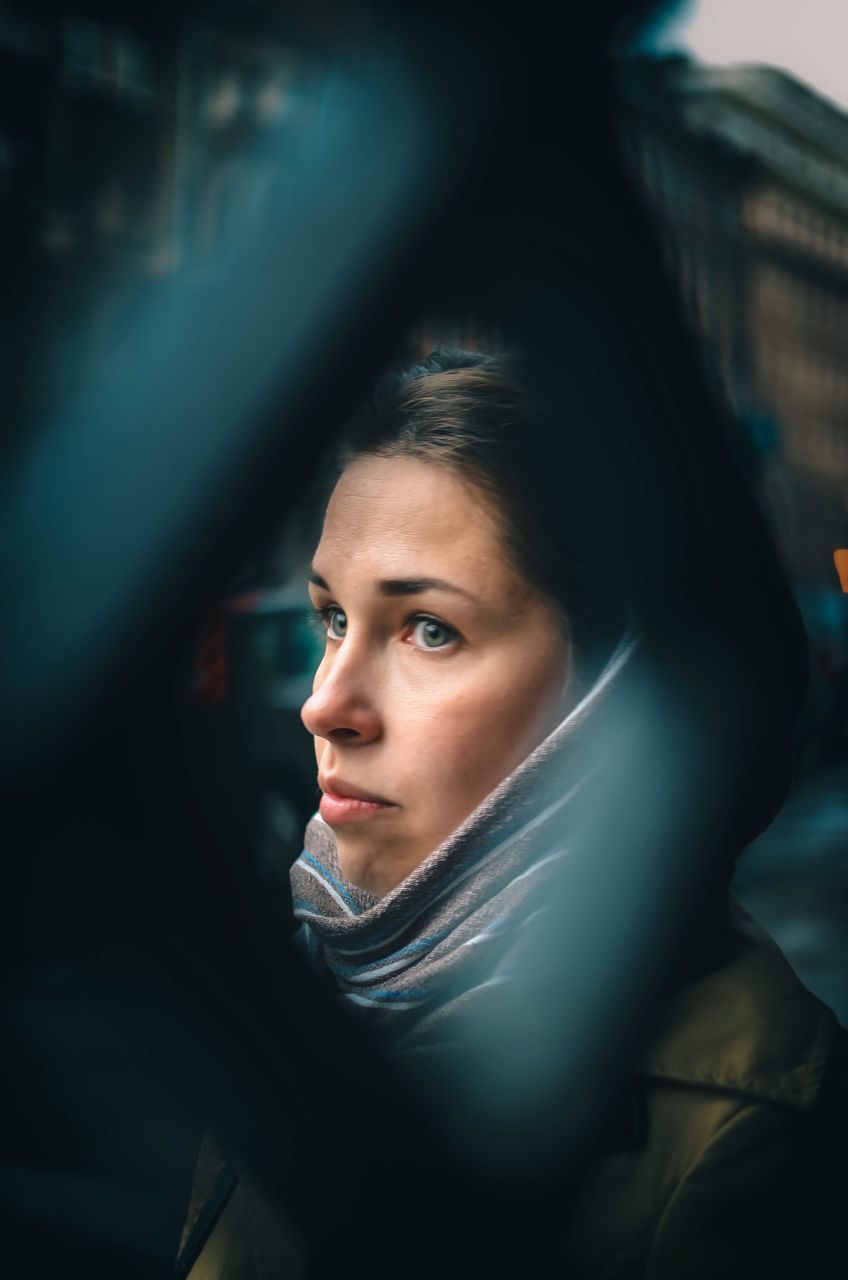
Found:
[734,760,848,1027]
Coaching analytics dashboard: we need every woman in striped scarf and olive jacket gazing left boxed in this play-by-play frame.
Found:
[184,351,842,1280]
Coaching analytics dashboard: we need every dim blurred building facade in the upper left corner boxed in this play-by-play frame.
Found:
[0,0,320,412]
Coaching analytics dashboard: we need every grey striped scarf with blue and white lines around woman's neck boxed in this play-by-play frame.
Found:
[291,632,638,1048]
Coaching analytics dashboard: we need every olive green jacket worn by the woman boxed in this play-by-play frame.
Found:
[175,902,848,1280]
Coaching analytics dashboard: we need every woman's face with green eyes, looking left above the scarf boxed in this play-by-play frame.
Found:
[301,458,569,896]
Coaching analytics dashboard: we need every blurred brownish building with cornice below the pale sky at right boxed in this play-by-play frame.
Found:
[619,56,848,752]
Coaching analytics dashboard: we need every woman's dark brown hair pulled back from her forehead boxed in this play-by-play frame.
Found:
[336,347,624,682]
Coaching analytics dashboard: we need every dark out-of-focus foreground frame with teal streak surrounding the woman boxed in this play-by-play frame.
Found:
[0,3,845,1277]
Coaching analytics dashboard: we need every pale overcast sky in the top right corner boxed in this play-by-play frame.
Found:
[656,0,848,108]
